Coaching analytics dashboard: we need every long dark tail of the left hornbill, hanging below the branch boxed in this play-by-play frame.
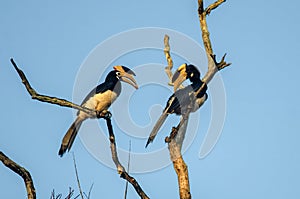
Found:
[58,118,83,157]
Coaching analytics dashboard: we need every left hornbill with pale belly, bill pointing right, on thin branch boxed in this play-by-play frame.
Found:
[58,66,138,156]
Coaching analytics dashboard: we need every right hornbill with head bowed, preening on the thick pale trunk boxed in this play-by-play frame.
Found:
[146,64,207,147]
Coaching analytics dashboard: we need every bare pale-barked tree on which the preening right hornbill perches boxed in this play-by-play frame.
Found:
[164,0,230,199]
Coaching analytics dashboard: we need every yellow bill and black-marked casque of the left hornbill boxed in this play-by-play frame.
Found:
[114,65,138,89]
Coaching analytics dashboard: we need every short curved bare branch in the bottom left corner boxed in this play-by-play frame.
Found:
[0,151,36,199]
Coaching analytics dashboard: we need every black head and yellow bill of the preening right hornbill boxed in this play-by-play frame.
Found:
[172,64,200,92]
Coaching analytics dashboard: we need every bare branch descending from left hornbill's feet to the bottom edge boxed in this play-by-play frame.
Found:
[105,118,149,199]
